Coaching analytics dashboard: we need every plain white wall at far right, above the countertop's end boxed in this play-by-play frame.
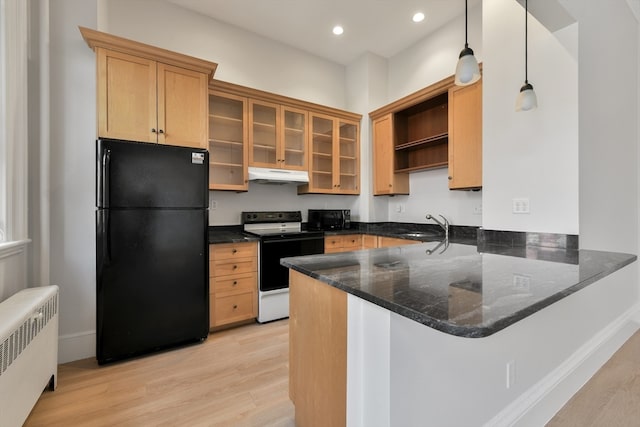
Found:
[563,0,639,254]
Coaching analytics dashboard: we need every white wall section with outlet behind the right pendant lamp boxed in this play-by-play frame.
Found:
[482,0,578,234]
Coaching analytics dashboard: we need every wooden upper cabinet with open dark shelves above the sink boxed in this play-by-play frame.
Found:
[369,72,482,196]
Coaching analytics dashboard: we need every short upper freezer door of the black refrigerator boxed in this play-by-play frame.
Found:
[96,139,209,209]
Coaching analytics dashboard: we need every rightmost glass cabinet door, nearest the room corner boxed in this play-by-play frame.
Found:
[335,121,360,194]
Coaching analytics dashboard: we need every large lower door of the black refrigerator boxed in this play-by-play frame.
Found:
[96,209,209,363]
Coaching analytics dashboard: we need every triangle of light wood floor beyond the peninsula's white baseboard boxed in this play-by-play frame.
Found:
[547,331,640,427]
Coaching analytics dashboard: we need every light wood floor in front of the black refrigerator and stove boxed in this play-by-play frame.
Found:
[25,320,294,427]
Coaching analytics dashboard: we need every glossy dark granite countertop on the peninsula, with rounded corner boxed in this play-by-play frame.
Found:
[281,242,636,338]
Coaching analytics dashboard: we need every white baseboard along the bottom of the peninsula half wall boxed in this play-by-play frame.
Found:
[485,304,640,427]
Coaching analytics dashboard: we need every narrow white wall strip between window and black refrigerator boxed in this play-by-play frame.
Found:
[48,0,97,363]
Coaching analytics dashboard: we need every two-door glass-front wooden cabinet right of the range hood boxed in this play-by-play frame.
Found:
[298,114,360,194]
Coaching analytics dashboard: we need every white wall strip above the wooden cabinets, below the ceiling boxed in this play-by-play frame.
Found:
[99,0,346,109]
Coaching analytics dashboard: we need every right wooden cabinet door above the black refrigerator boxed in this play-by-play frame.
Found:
[158,63,209,149]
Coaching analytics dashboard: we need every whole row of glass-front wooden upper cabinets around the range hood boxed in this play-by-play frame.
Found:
[209,80,362,194]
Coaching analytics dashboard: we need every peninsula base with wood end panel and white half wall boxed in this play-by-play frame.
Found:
[290,269,639,427]
